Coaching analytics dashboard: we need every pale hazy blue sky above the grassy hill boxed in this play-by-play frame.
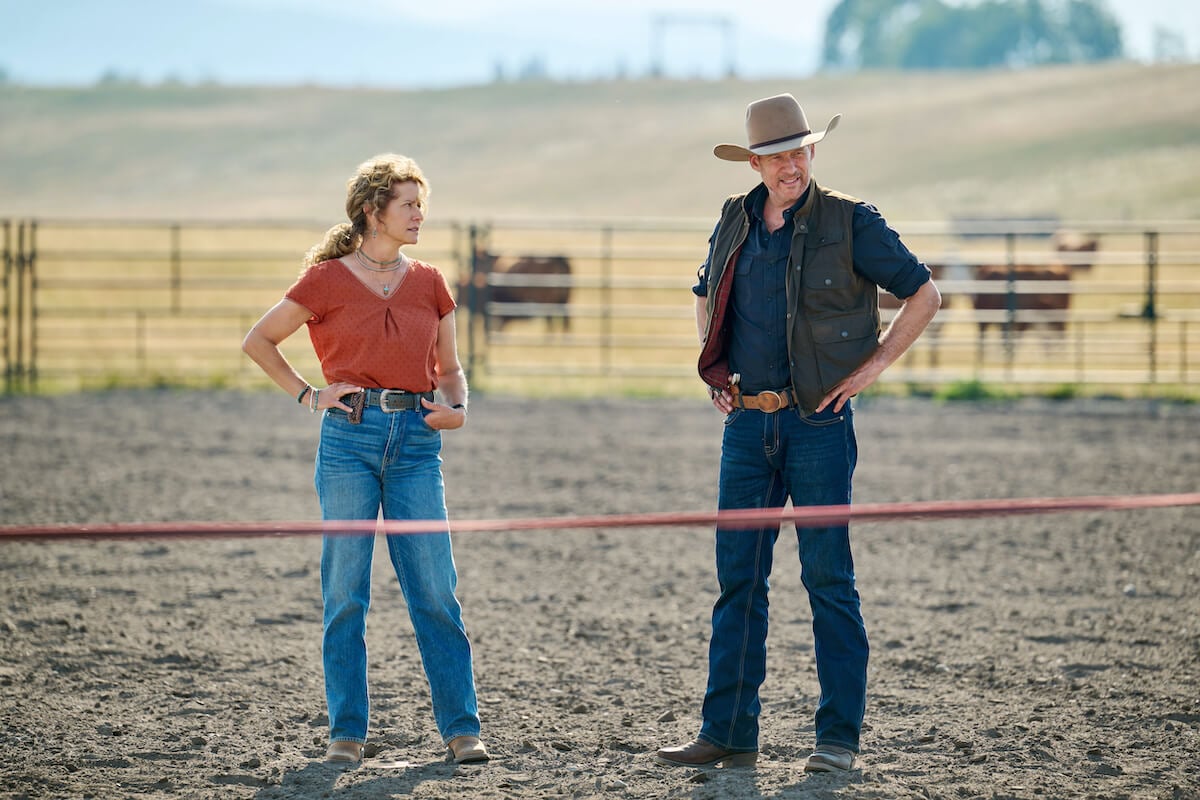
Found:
[0,0,1200,89]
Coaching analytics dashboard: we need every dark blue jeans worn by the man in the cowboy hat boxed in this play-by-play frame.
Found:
[700,404,868,752]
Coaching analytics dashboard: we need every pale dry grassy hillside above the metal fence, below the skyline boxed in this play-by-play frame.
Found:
[0,64,1200,223]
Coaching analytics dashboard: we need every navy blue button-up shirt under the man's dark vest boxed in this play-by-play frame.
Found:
[692,184,930,395]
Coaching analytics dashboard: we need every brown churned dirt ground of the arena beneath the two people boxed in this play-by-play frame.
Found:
[0,391,1200,800]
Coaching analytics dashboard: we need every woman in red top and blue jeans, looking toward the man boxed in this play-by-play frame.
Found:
[242,154,488,764]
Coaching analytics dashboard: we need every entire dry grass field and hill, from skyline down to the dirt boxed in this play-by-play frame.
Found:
[0,34,1200,398]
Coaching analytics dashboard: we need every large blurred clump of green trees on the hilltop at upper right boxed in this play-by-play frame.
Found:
[822,0,1123,70]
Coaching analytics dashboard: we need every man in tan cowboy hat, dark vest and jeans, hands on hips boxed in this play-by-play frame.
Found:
[656,95,941,771]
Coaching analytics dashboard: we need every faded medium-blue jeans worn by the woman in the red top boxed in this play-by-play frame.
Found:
[316,407,479,742]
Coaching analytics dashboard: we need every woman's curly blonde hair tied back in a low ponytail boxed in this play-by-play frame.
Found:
[304,152,430,269]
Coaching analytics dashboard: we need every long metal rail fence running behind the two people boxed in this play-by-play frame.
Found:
[0,219,1200,393]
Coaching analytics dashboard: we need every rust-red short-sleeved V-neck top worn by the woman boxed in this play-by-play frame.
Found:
[284,259,455,392]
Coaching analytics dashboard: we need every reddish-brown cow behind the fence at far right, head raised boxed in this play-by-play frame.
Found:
[971,233,1099,345]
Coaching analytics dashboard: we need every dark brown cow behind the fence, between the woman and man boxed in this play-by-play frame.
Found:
[458,248,571,333]
